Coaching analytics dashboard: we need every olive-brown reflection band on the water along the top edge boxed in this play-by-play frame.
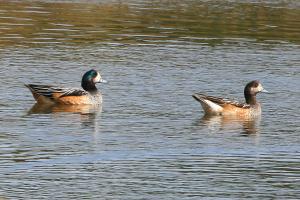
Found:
[0,1,300,47]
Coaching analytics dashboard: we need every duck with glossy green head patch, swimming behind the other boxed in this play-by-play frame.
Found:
[25,69,107,105]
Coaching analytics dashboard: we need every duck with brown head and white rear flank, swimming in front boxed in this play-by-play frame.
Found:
[192,80,268,117]
